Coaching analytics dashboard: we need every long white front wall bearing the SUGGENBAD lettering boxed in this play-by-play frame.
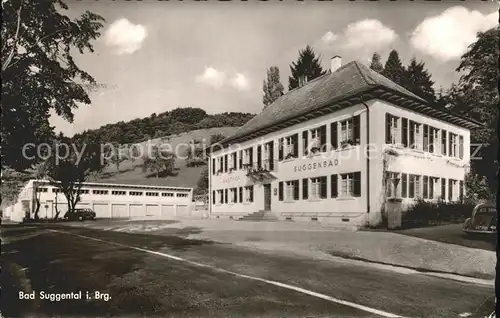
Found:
[209,105,367,222]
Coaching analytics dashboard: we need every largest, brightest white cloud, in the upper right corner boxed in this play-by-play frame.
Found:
[410,6,498,62]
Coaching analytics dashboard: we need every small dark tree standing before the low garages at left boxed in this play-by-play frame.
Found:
[47,134,105,219]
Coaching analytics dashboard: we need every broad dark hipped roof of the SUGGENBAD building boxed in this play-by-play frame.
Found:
[222,61,481,145]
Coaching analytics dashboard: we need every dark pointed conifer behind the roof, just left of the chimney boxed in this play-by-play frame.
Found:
[288,45,326,90]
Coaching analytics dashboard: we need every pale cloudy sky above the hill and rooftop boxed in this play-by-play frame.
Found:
[51,0,498,136]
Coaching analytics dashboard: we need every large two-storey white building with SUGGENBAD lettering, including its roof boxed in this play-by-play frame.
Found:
[209,57,479,226]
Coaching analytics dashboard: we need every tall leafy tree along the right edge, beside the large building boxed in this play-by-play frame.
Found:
[446,28,500,189]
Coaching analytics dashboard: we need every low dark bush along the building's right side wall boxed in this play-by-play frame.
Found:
[402,200,475,228]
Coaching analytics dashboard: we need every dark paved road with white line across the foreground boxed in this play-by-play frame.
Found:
[0,225,494,317]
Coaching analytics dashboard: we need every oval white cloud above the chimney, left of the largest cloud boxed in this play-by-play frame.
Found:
[342,19,398,52]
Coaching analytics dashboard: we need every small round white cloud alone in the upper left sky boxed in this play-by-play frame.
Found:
[104,18,148,55]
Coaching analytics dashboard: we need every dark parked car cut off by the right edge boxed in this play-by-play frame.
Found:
[462,203,498,234]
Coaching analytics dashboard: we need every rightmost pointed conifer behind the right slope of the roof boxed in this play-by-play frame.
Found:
[403,58,436,102]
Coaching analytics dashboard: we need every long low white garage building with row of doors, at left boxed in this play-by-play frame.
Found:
[4,180,193,222]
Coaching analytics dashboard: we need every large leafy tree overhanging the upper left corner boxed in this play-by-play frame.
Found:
[1,0,104,169]
